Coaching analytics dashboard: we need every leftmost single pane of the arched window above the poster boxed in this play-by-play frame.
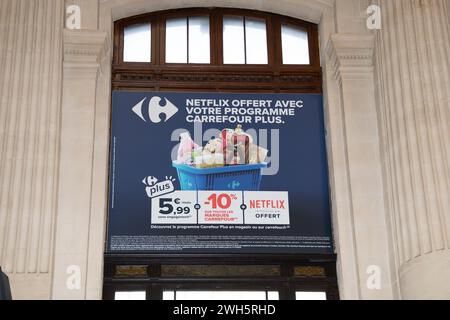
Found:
[123,24,152,62]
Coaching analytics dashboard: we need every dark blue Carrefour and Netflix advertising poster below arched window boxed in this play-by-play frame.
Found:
[107,91,333,254]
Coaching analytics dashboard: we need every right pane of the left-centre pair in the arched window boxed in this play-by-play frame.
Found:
[189,17,211,63]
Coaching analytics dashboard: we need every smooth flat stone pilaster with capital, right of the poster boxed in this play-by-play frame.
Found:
[327,34,394,299]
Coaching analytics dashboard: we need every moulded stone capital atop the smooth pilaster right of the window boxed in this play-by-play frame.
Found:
[326,34,375,81]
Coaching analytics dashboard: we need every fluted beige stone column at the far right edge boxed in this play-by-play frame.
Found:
[376,0,450,299]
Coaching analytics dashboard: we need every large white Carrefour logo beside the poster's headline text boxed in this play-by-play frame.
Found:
[132,96,178,123]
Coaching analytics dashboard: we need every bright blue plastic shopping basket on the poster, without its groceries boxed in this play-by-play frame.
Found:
[173,162,267,191]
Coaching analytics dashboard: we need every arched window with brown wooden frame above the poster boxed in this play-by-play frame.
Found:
[113,8,322,93]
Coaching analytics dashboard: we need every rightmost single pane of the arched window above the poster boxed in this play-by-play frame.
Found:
[281,26,309,64]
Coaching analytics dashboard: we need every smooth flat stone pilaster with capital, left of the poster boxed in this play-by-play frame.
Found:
[52,30,106,299]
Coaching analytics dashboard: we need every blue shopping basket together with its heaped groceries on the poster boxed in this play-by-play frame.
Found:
[172,125,268,191]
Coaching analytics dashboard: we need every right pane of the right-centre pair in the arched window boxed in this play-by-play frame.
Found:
[245,18,267,64]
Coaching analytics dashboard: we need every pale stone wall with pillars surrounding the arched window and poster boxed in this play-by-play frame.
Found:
[0,0,450,299]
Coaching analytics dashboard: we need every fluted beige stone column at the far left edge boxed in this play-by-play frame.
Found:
[0,0,64,299]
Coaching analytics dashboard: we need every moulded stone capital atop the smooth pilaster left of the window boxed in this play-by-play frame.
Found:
[63,29,108,79]
